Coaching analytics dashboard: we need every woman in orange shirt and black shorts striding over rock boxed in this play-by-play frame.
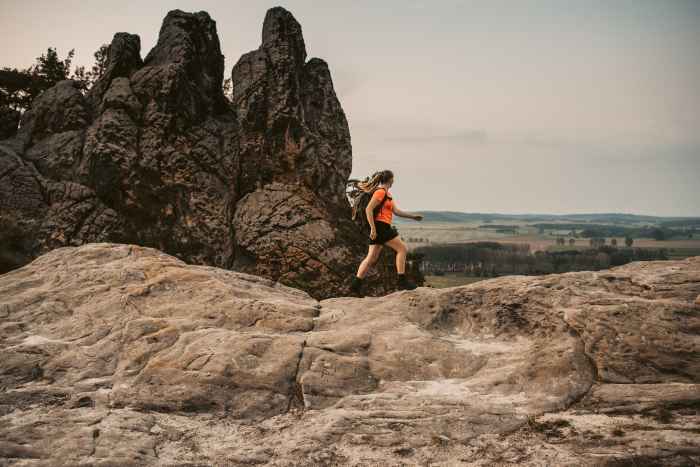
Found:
[350,170,423,295]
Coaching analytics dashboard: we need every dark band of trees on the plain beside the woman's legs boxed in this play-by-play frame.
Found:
[413,242,668,277]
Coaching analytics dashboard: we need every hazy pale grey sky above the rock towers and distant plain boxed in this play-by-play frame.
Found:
[0,0,700,216]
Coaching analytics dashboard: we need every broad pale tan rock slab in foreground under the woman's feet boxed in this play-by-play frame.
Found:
[0,243,700,466]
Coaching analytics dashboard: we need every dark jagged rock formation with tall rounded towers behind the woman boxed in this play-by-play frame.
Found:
[0,7,416,298]
